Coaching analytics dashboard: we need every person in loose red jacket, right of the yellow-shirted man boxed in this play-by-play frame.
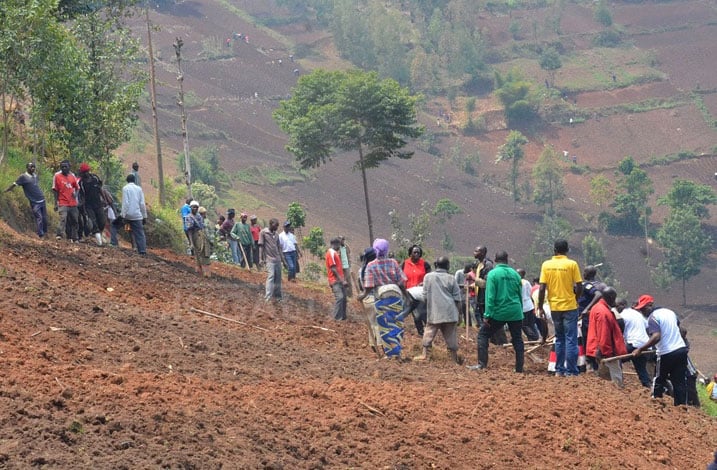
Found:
[587,287,627,388]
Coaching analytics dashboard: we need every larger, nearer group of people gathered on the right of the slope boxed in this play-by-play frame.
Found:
[346,239,704,406]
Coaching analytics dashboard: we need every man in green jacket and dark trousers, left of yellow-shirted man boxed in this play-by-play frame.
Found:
[473,251,525,372]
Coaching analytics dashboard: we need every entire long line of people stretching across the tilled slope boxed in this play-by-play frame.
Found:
[5,165,717,412]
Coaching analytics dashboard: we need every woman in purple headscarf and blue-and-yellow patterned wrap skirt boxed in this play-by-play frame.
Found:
[358,238,406,359]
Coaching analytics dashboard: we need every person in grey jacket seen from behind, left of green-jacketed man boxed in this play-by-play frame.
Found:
[413,256,463,364]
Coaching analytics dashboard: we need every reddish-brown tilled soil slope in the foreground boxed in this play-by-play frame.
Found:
[0,224,717,469]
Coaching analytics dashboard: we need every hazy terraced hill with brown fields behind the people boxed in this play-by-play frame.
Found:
[122,0,717,370]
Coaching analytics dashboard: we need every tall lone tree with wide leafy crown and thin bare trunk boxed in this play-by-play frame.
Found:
[273,70,423,242]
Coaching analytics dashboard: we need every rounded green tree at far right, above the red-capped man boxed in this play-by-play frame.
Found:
[657,210,712,305]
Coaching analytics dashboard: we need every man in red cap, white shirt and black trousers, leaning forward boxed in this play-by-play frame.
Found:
[632,294,687,405]
